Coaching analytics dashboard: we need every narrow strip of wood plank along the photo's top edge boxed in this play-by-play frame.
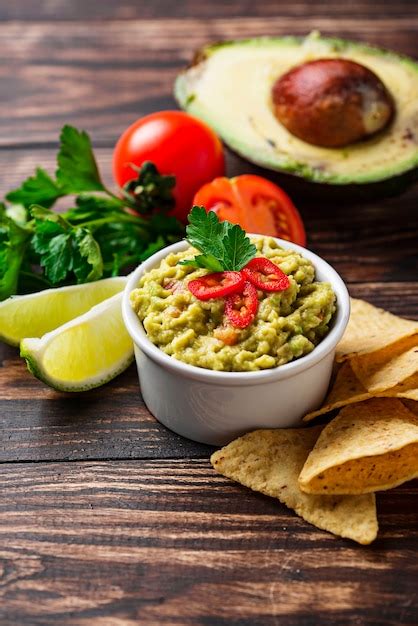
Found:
[0,0,418,22]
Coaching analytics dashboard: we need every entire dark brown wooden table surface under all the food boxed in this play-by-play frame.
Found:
[0,0,418,626]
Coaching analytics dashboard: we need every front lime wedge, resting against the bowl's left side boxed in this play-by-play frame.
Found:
[20,293,133,391]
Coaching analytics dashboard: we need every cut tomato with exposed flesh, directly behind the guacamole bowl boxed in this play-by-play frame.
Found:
[193,174,306,246]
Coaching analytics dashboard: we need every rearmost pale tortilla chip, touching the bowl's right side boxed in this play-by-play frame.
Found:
[336,298,418,361]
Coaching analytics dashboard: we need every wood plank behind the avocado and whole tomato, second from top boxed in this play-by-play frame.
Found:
[0,18,418,146]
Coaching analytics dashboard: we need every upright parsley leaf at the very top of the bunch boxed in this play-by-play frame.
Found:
[56,125,105,194]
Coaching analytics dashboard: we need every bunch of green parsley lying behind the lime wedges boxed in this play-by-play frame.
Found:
[0,126,183,300]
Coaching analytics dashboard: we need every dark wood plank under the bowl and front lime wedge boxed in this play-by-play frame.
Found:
[0,283,418,462]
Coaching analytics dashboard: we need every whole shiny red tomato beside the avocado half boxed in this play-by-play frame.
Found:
[113,111,225,221]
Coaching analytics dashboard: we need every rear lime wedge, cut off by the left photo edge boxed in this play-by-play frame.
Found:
[0,276,126,346]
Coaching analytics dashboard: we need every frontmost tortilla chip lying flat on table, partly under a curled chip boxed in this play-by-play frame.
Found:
[211,426,378,544]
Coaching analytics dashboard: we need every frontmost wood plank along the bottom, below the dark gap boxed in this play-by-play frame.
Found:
[0,460,418,626]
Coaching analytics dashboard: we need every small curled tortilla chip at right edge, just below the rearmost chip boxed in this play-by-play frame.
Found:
[350,335,418,394]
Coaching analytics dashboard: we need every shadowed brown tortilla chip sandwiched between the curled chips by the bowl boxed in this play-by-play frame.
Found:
[303,361,418,422]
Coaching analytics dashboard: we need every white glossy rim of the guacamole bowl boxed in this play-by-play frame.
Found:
[122,233,350,386]
